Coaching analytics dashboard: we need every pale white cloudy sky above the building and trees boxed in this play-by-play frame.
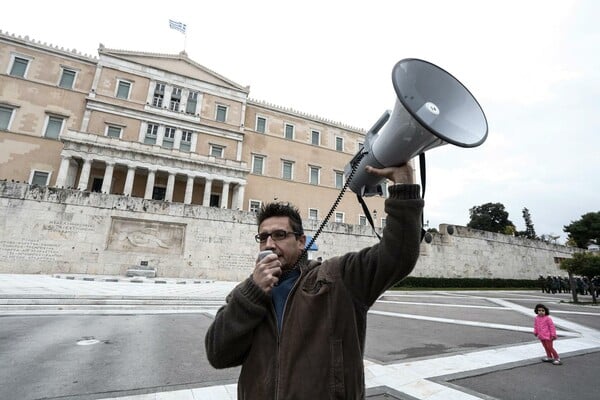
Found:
[0,0,600,242]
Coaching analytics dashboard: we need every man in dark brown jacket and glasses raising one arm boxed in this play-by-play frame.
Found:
[205,165,423,400]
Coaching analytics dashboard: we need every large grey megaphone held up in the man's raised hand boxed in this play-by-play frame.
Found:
[344,58,488,196]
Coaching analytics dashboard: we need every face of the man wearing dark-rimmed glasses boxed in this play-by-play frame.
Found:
[258,217,306,270]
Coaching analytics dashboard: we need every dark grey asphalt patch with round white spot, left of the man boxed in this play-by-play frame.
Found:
[0,314,239,400]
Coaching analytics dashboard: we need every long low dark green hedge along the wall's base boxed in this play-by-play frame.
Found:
[393,276,540,289]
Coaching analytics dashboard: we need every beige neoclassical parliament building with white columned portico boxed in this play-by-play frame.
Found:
[0,31,385,228]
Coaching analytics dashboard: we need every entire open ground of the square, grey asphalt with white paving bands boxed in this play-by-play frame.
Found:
[0,275,600,400]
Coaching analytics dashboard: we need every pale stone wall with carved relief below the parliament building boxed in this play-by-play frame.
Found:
[0,182,572,281]
